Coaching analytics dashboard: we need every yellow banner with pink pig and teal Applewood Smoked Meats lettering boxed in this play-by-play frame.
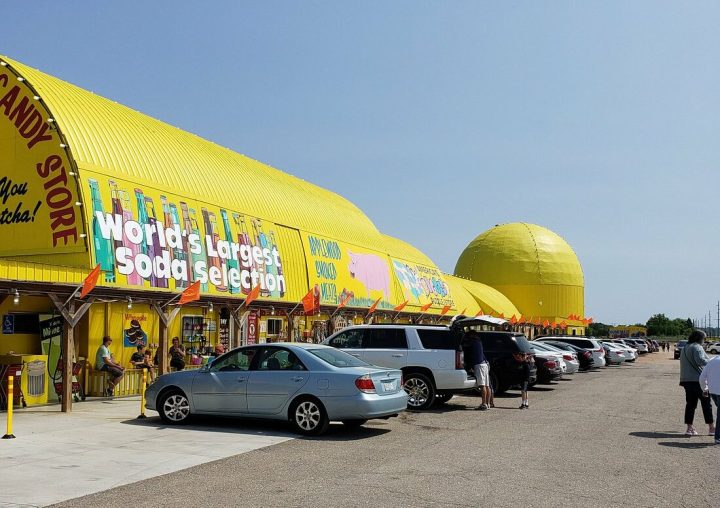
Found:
[302,234,400,310]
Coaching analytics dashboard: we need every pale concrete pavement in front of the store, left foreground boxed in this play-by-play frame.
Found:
[0,397,294,508]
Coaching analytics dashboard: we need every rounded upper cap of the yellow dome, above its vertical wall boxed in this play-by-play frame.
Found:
[455,222,584,287]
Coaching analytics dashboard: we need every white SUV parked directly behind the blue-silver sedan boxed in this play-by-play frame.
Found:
[323,325,475,409]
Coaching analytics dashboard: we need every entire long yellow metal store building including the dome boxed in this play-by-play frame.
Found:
[0,56,583,410]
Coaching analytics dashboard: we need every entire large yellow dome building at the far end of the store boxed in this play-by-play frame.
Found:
[455,222,584,318]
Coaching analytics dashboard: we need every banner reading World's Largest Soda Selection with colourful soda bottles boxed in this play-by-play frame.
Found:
[88,171,287,300]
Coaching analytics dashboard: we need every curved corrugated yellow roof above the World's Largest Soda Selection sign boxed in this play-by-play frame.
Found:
[2,57,382,249]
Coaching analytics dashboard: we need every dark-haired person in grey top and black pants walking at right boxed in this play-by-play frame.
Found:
[680,330,715,436]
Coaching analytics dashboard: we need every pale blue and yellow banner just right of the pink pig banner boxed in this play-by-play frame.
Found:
[392,259,455,308]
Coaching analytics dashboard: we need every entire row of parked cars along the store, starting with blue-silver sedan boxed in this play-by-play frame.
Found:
[146,318,650,435]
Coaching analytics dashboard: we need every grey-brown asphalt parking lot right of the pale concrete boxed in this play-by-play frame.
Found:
[57,353,720,507]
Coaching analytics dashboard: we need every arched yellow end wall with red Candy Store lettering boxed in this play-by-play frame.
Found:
[0,67,87,256]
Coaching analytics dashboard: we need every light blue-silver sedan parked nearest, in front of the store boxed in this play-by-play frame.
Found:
[146,343,407,435]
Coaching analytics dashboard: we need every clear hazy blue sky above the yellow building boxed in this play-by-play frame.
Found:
[0,0,720,323]
